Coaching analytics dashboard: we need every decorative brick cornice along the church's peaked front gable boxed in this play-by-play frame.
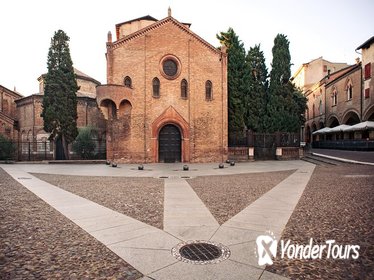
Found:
[107,16,221,53]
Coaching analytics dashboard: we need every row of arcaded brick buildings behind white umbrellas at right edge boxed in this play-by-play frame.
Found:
[293,37,374,143]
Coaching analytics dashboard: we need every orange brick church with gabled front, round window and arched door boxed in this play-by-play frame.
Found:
[97,10,228,162]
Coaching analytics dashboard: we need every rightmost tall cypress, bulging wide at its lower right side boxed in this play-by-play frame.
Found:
[265,34,306,132]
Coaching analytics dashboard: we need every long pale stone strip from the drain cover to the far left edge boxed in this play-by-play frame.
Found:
[2,166,181,275]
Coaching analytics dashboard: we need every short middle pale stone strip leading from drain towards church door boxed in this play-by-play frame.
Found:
[164,178,219,241]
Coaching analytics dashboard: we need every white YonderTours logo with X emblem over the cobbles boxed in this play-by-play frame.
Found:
[256,233,360,265]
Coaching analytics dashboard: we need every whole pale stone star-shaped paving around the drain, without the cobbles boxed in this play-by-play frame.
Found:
[1,161,315,280]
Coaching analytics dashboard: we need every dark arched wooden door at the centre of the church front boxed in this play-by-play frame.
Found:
[158,124,182,162]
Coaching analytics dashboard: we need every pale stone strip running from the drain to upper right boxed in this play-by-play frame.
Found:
[211,164,315,268]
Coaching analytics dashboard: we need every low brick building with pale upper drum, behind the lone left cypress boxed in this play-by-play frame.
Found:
[15,69,106,160]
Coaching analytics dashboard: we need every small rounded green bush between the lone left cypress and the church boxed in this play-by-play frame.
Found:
[73,127,96,159]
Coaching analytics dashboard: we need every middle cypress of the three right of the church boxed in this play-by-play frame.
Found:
[245,45,268,132]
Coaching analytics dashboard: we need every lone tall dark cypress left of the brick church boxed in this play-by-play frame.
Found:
[41,30,79,159]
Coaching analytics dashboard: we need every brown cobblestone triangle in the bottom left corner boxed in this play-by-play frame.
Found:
[0,168,142,280]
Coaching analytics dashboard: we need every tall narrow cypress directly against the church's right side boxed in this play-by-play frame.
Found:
[217,28,248,134]
